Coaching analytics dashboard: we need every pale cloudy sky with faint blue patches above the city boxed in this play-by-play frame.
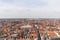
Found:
[0,0,60,18]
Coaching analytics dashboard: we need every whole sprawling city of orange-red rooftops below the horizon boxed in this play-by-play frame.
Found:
[0,19,60,40]
